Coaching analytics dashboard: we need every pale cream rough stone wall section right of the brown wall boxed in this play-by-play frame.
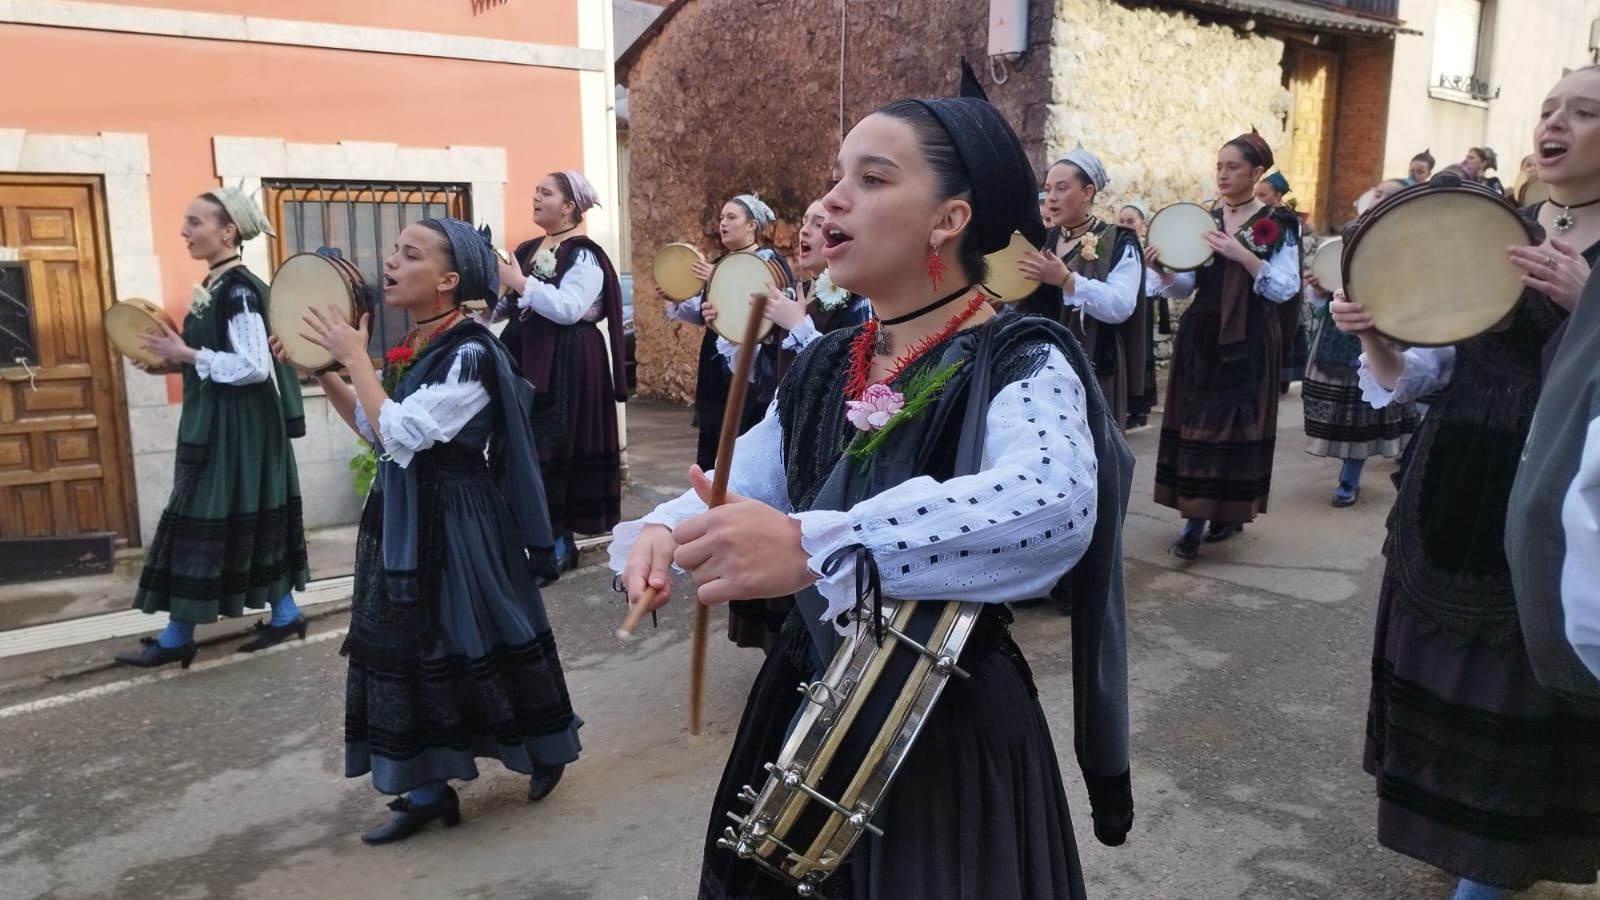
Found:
[1045,0,1290,213]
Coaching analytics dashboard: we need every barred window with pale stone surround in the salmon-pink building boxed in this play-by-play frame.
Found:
[262,181,472,359]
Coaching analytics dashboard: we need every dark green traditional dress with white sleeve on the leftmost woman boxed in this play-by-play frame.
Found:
[133,266,309,625]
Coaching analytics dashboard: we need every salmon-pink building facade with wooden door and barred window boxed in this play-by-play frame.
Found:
[0,0,618,546]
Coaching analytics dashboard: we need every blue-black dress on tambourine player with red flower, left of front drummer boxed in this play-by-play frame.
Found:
[342,322,582,794]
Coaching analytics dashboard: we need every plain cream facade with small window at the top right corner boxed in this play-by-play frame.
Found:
[1384,0,1600,187]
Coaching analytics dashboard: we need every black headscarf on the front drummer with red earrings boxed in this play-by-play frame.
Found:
[917,96,1045,255]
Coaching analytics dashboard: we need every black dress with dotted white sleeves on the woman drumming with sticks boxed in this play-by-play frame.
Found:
[613,315,1131,900]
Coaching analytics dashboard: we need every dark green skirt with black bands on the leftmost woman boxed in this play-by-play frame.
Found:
[133,381,310,625]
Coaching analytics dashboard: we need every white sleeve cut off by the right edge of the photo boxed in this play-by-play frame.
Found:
[1562,418,1600,677]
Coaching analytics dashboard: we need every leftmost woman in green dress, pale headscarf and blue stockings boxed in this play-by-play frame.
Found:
[117,187,309,668]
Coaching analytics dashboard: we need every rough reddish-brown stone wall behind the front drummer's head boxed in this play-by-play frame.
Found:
[627,0,1051,399]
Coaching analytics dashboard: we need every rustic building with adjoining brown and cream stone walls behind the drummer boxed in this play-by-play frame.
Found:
[618,0,1403,399]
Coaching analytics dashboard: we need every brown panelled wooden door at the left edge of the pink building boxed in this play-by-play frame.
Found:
[0,176,138,543]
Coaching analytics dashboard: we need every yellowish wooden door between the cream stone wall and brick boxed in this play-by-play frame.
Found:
[1280,48,1339,231]
